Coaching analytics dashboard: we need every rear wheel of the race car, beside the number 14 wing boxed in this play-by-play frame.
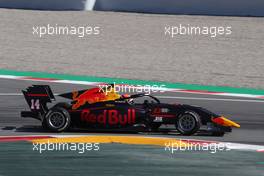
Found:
[44,107,71,132]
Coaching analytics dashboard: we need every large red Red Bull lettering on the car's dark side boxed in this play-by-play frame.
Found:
[81,109,136,125]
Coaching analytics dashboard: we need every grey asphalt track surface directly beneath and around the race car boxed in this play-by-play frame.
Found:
[0,79,264,145]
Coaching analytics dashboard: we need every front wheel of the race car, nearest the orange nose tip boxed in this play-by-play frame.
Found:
[175,111,201,135]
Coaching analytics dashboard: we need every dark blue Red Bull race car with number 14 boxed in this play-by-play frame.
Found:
[21,85,240,136]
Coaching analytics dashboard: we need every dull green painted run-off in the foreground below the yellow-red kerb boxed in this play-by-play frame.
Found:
[0,142,264,176]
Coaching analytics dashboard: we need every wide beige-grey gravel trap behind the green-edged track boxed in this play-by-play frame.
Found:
[0,9,264,88]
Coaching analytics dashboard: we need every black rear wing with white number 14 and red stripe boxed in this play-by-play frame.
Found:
[22,85,55,115]
